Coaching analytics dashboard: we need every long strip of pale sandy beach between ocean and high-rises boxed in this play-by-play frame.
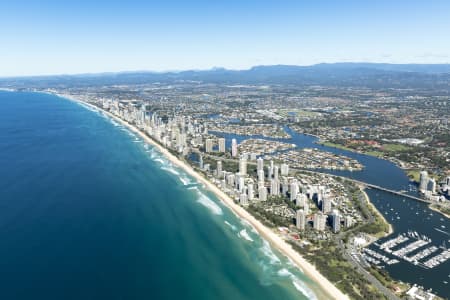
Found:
[60,94,349,299]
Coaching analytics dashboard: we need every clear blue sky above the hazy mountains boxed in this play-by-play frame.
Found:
[0,0,450,76]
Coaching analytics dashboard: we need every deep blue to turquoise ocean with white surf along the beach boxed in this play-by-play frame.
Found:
[0,92,323,299]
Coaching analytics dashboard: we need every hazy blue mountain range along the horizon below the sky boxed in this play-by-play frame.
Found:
[0,63,450,90]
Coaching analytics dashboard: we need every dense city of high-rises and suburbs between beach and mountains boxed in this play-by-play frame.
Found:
[0,66,450,299]
